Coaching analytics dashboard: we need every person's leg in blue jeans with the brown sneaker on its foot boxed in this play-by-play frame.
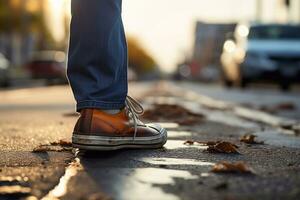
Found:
[68,0,167,150]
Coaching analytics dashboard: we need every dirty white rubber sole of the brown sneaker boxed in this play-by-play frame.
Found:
[72,129,167,151]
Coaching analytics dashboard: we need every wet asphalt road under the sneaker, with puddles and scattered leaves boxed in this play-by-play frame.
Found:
[0,83,300,200]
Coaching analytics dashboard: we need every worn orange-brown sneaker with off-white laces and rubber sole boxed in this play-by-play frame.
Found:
[72,97,167,150]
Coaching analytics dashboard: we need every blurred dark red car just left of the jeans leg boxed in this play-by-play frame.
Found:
[27,51,67,84]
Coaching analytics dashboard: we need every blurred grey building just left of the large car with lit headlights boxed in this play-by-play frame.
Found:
[178,22,236,80]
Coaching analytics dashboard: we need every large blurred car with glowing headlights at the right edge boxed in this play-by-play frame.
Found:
[221,24,300,90]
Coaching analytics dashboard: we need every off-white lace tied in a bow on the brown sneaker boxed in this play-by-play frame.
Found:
[125,96,144,140]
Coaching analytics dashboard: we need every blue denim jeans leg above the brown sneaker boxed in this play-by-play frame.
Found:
[67,0,128,111]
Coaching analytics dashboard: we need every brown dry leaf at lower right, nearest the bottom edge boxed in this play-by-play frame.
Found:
[211,161,253,174]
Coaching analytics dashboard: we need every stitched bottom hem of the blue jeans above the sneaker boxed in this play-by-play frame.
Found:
[76,100,125,112]
